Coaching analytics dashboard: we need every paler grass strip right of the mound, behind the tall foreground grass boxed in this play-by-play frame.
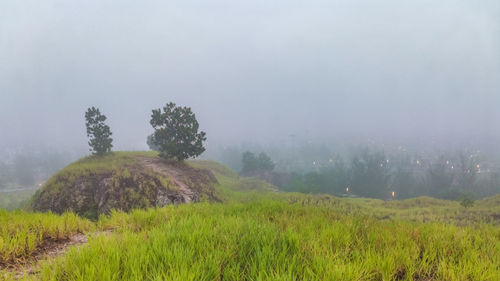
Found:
[193,158,500,225]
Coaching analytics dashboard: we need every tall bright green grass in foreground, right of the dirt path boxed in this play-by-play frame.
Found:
[6,200,500,281]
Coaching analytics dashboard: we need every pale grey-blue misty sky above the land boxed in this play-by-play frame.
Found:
[0,0,500,149]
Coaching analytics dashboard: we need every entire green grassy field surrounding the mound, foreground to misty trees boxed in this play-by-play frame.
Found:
[0,153,500,281]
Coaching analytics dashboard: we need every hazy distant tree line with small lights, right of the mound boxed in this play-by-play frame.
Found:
[237,148,500,200]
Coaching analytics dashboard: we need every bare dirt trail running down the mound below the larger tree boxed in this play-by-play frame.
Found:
[137,157,195,203]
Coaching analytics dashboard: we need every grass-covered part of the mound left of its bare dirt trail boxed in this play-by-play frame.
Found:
[28,152,192,220]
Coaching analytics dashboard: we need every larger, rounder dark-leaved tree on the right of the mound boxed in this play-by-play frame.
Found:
[150,102,207,161]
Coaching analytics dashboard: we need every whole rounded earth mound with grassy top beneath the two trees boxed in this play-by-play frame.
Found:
[30,152,219,219]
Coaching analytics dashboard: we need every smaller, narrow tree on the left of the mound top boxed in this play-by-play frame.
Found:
[85,107,113,155]
